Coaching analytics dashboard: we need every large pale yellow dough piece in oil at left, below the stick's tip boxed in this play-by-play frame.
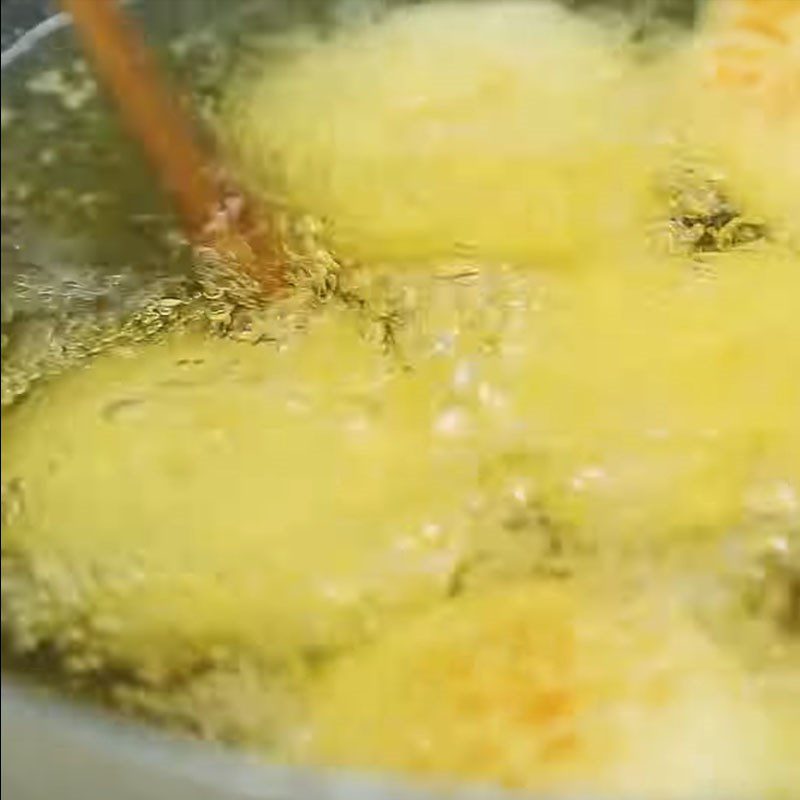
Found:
[3,314,474,684]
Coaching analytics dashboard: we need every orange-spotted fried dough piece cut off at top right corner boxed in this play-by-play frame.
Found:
[683,0,800,238]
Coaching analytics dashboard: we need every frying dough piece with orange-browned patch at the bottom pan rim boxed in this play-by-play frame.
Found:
[299,582,764,798]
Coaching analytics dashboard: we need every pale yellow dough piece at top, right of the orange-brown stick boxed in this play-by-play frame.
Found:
[226,0,664,266]
